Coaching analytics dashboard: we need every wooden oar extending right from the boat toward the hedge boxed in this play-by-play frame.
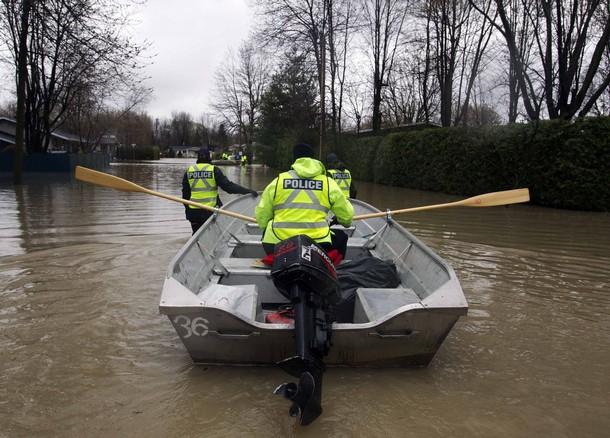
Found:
[353,189,530,220]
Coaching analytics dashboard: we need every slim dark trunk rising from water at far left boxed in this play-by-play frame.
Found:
[13,0,33,184]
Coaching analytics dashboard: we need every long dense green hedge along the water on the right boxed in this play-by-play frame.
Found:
[336,117,610,211]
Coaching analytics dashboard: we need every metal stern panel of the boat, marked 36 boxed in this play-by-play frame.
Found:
[168,309,459,367]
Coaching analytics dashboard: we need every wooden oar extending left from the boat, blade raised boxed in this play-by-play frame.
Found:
[74,166,256,222]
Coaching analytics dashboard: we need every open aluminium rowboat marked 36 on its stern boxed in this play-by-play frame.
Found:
[159,196,468,367]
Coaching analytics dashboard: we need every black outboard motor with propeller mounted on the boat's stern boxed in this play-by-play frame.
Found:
[271,235,339,425]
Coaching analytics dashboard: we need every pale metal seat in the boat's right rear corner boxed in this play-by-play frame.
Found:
[354,287,421,323]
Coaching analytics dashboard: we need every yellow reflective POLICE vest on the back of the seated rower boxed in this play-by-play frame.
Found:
[271,170,331,240]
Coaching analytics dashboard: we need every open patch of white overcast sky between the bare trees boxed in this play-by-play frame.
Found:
[134,0,253,118]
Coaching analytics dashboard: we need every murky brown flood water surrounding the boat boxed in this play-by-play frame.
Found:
[0,160,610,437]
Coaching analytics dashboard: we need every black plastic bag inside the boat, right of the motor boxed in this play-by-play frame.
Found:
[334,257,400,322]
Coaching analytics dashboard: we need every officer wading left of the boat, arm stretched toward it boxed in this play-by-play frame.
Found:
[182,148,258,234]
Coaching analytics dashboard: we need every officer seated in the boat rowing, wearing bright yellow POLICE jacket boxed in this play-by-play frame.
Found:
[255,144,354,257]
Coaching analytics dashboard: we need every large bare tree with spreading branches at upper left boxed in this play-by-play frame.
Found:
[0,0,143,152]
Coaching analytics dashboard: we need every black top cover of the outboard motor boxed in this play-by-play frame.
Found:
[271,235,340,307]
